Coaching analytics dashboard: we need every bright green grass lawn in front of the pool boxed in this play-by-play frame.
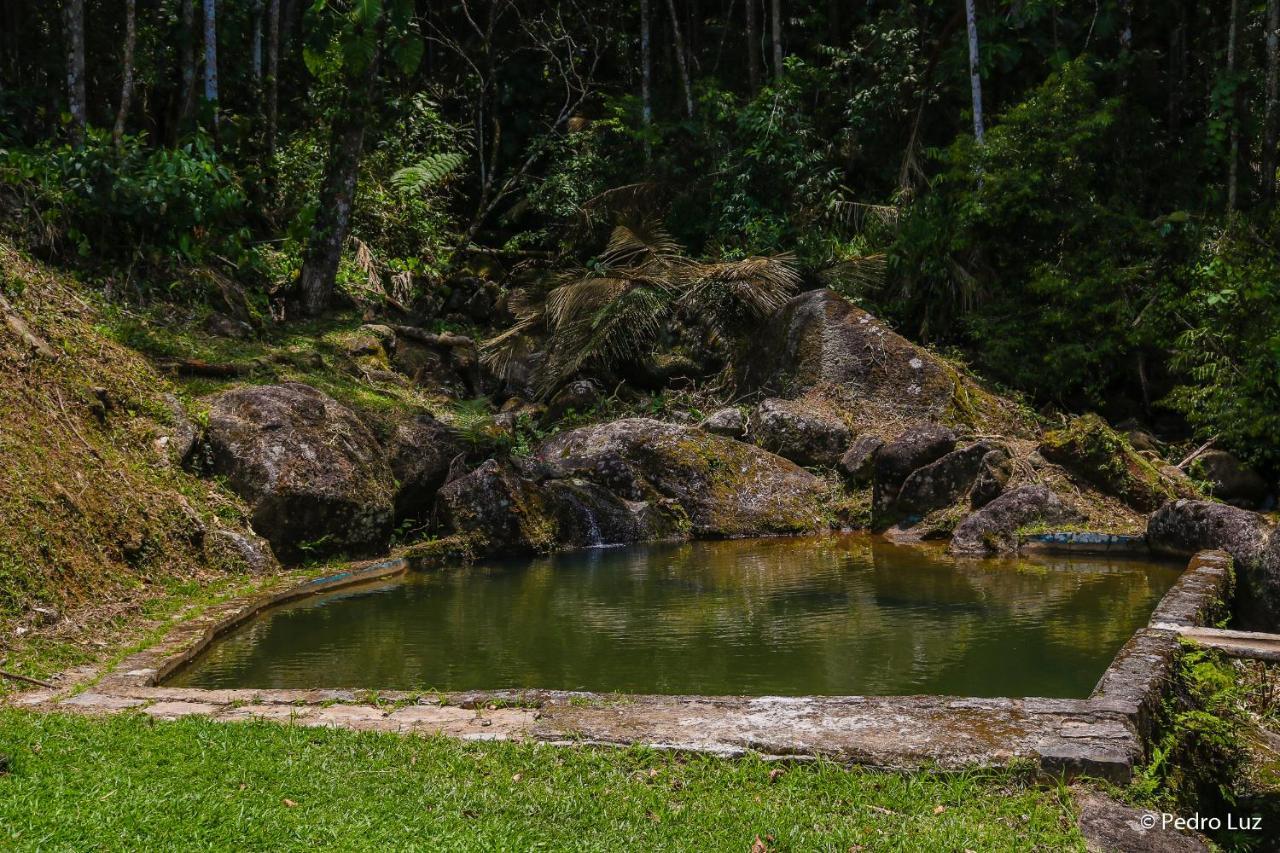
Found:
[0,710,1083,852]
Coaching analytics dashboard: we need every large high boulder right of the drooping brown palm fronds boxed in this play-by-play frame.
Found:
[737,289,957,419]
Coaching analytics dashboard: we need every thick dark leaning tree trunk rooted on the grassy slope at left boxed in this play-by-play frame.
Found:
[298,40,381,316]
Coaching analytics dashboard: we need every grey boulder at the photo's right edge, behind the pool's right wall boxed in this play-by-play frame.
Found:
[1147,501,1280,631]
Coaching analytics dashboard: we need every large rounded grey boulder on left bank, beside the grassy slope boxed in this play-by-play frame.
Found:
[205,382,394,561]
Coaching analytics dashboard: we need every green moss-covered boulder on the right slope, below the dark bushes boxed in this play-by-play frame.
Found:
[1039,414,1187,512]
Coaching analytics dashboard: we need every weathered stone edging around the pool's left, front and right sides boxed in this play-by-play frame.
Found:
[7,551,1231,783]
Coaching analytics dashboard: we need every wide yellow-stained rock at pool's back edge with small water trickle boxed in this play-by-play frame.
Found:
[439,418,824,555]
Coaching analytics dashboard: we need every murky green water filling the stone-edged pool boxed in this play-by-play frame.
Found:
[168,535,1179,698]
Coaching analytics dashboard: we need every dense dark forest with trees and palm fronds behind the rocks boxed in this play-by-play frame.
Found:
[0,0,1280,473]
